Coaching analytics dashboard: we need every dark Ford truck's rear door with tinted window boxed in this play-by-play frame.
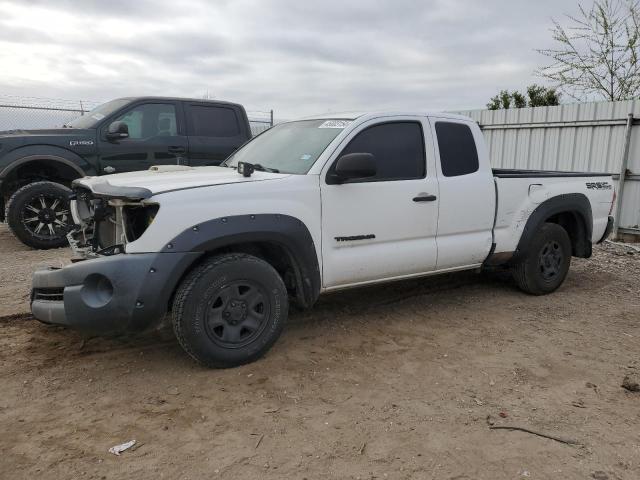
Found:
[184,102,251,166]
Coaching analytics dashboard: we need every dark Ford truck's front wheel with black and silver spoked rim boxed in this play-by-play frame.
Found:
[5,182,73,249]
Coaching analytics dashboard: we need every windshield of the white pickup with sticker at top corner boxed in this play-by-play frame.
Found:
[223,119,351,174]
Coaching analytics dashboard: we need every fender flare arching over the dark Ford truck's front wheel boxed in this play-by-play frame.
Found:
[0,145,95,179]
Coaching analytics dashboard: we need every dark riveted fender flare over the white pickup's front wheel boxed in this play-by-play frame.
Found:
[161,213,321,307]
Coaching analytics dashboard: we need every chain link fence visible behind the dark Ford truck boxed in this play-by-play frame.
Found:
[0,95,273,135]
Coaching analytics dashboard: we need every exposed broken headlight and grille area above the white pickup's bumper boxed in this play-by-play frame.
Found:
[67,181,159,258]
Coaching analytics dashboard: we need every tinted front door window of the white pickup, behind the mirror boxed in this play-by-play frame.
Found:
[340,122,426,182]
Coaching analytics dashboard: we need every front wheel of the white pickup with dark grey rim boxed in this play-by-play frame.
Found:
[172,253,289,368]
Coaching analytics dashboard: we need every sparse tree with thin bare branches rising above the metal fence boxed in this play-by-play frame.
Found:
[536,0,640,101]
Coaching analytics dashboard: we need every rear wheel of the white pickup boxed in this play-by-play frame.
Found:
[512,223,571,295]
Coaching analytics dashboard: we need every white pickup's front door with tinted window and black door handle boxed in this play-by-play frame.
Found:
[320,116,439,289]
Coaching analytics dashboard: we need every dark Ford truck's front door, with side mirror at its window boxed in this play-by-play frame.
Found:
[98,101,188,174]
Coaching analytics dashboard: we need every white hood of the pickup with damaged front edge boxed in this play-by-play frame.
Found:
[73,165,289,198]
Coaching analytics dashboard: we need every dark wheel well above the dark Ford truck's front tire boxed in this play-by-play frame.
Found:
[1,159,80,202]
